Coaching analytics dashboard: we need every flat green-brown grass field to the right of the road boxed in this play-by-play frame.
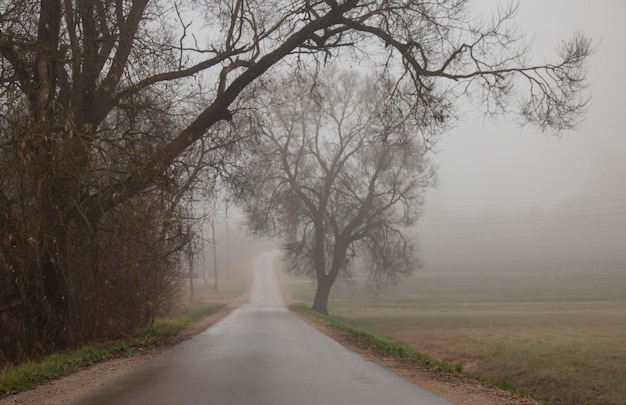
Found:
[286,275,626,405]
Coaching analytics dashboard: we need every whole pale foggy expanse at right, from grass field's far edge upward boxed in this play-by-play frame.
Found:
[417,0,626,274]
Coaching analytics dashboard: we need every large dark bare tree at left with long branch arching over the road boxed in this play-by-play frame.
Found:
[0,0,590,357]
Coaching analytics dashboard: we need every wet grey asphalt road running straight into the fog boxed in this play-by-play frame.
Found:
[76,252,452,405]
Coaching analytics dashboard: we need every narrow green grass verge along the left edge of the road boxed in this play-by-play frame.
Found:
[0,304,223,396]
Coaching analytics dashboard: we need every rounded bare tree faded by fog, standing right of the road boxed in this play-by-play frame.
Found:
[234,70,437,313]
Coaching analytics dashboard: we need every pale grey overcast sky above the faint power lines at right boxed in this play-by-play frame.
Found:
[426,0,626,210]
